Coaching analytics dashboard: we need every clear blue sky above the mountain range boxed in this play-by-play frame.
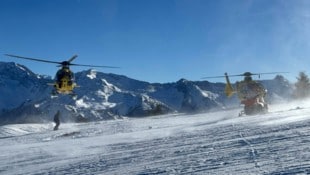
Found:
[0,0,310,83]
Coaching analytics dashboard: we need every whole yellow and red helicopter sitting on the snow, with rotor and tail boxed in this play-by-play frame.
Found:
[203,72,288,116]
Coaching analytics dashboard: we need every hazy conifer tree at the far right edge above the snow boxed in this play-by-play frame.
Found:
[294,72,310,99]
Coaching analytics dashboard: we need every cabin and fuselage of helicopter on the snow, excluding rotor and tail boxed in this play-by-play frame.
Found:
[236,72,268,115]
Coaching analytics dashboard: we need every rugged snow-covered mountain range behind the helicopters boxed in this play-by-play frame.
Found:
[0,62,292,124]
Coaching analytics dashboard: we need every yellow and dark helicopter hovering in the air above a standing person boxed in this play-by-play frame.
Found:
[4,54,119,98]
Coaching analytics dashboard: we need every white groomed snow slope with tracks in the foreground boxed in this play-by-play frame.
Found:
[0,101,310,175]
